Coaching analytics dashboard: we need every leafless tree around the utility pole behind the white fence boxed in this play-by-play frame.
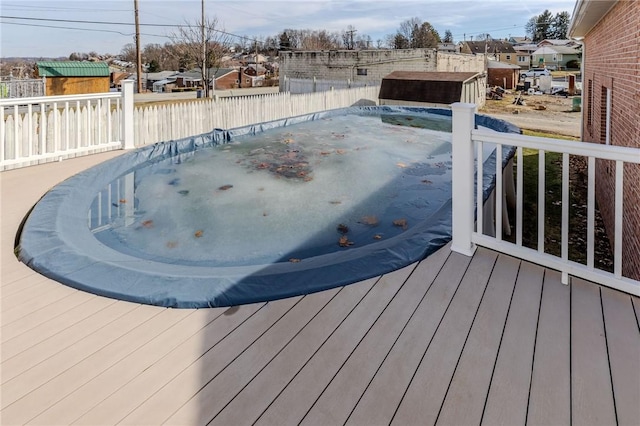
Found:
[169,17,231,97]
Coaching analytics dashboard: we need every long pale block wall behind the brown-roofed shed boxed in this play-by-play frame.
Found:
[280,49,484,85]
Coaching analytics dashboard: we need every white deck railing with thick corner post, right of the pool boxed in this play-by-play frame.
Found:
[452,103,640,295]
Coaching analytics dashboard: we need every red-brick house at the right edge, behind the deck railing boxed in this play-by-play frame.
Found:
[569,0,640,280]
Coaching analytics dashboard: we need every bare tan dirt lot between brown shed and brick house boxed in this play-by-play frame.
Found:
[479,93,581,137]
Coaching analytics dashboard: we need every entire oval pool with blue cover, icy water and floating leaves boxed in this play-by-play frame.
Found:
[18,107,517,308]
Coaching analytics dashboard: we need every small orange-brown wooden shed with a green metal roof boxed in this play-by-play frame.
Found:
[36,61,110,96]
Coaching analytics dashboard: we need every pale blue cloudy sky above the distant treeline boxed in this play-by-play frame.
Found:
[0,0,576,57]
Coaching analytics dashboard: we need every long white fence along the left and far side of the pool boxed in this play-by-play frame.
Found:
[0,81,379,170]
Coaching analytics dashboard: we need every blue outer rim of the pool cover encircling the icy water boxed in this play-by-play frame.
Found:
[16,106,519,308]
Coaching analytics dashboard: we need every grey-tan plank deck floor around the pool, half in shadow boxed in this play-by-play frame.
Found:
[0,153,640,425]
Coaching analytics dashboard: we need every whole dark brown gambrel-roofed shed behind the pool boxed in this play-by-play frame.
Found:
[378,71,487,107]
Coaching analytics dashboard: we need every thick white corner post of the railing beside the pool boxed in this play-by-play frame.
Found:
[451,102,476,256]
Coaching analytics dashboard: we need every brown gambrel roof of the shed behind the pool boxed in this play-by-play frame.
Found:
[378,71,479,104]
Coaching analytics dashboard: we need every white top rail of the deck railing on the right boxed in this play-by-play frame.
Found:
[471,129,640,164]
